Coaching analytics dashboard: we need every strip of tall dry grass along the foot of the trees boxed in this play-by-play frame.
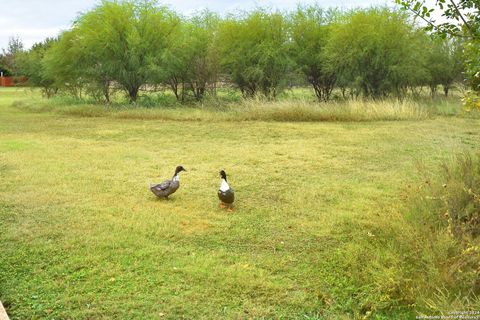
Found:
[15,99,433,122]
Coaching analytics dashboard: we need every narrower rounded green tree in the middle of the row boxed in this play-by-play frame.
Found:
[219,9,292,99]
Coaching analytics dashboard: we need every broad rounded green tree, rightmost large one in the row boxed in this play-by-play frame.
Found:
[326,8,424,98]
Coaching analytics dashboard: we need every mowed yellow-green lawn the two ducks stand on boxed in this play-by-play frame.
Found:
[0,90,480,319]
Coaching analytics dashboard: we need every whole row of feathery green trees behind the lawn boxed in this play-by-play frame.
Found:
[6,0,472,102]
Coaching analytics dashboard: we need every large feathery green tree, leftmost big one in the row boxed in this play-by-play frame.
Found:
[47,1,180,102]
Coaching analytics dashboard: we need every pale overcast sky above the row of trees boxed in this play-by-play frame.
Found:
[0,0,393,48]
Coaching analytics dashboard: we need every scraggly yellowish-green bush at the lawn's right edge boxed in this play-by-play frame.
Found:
[408,152,480,311]
